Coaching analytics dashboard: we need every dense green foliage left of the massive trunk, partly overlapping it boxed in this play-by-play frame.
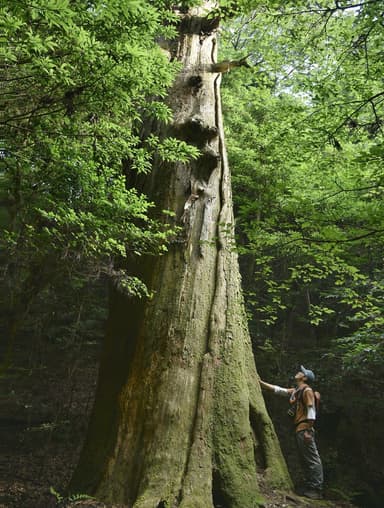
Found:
[0,0,201,352]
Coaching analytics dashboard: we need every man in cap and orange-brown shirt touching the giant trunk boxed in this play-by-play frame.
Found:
[260,365,323,499]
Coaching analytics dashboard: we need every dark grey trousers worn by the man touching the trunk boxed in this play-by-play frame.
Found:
[296,429,323,490]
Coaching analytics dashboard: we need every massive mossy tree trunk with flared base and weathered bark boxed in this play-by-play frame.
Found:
[71,2,290,508]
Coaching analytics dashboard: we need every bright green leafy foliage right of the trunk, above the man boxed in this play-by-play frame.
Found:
[220,1,384,380]
